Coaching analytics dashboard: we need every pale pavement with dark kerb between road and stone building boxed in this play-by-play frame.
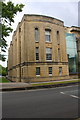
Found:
[0,79,78,91]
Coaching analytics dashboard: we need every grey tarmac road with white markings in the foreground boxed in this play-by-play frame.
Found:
[2,85,80,118]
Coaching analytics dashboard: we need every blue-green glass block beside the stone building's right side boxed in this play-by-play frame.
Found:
[66,33,78,74]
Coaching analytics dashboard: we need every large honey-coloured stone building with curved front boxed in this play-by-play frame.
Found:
[8,14,69,82]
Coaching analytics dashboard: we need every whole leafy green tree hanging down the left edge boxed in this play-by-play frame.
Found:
[0,1,24,61]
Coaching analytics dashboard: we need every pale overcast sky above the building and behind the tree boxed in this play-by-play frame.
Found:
[0,0,79,67]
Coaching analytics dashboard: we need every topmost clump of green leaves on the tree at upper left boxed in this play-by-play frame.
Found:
[2,1,24,25]
